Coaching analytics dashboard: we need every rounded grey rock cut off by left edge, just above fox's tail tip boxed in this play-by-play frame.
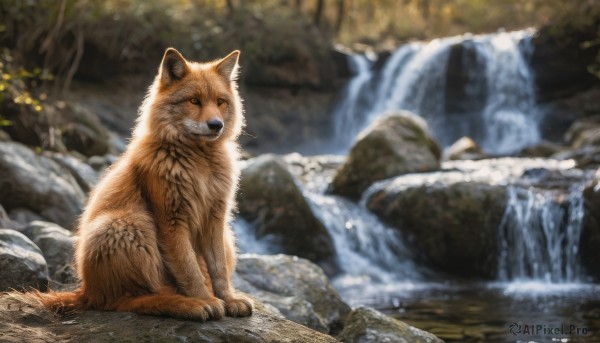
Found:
[0,229,48,292]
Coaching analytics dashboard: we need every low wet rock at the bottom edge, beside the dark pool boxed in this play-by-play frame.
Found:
[338,307,444,343]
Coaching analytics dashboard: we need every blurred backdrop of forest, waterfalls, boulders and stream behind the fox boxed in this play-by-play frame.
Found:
[0,0,600,342]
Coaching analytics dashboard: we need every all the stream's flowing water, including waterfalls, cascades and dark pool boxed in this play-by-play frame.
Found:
[234,30,600,342]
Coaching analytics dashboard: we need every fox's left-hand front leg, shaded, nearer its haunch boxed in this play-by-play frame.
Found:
[159,226,225,319]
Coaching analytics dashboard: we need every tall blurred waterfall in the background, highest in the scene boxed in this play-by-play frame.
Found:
[333,31,540,154]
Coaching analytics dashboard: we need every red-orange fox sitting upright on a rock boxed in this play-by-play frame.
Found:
[31,48,252,321]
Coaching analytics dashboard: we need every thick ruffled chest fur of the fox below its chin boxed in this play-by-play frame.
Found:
[142,143,236,241]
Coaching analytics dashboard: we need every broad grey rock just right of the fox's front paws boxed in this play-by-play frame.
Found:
[236,254,350,334]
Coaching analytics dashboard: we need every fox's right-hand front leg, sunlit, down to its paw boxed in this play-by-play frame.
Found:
[202,216,252,317]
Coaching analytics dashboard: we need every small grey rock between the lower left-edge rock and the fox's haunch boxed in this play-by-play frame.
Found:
[22,221,75,276]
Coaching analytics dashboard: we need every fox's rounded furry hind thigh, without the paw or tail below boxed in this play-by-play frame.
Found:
[76,210,165,310]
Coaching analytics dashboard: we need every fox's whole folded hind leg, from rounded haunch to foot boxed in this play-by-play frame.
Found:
[77,210,217,321]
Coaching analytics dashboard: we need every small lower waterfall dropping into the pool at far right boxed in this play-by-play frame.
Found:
[499,185,585,283]
